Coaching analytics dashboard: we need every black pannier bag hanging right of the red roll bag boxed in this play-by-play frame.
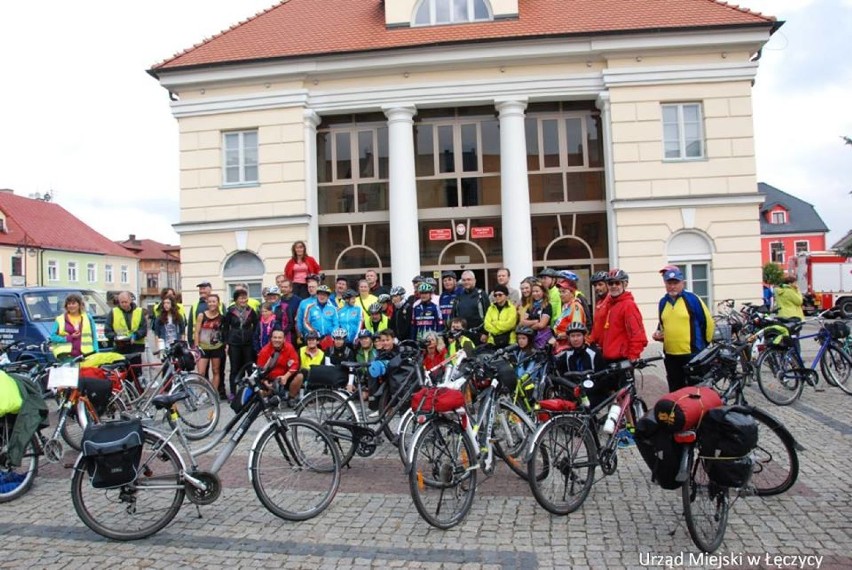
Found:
[698,407,758,487]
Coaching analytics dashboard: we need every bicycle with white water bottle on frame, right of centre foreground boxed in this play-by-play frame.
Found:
[526,356,662,515]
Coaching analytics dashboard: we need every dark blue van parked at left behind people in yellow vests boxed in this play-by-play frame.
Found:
[0,287,110,361]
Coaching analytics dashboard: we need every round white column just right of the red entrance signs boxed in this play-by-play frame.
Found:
[495,99,533,279]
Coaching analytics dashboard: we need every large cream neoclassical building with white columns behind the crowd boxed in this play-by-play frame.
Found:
[149,0,780,320]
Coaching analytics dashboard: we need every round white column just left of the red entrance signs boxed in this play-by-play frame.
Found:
[382,105,420,287]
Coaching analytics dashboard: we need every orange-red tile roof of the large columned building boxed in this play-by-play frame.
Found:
[151,0,776,74]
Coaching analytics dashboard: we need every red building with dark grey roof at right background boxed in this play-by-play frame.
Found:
[757,182,828,267]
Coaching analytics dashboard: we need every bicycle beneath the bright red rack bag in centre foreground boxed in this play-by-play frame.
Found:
[406,349,534,530]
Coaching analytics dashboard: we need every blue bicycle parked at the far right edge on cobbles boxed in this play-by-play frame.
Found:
[756,312,852,406]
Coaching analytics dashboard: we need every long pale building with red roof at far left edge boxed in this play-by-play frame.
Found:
[0,190,138,294]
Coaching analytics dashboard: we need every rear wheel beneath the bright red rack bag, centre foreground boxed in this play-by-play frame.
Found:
[408,417,477,530]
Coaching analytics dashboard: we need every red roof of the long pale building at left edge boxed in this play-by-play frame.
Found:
[0,192,133,257]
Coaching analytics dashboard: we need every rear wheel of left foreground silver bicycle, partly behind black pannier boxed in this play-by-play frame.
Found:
[71,429,185,541]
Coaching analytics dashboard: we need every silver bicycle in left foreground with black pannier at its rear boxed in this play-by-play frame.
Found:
[71,367,340,540]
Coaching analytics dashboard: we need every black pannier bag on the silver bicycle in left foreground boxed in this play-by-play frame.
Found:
[83,419,145,489]
